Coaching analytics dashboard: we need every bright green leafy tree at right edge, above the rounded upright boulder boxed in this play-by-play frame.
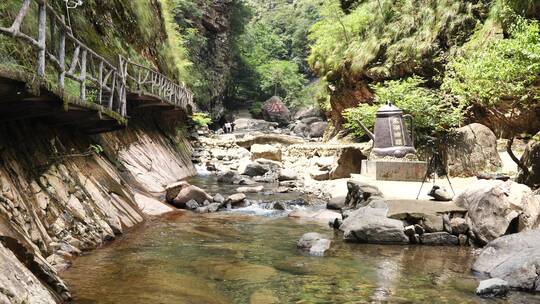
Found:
[443,17,540,107]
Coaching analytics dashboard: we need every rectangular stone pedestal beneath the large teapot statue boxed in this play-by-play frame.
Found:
[362,160,427,182]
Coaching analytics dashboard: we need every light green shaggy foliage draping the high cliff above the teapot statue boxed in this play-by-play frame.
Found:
[308,0,476,84]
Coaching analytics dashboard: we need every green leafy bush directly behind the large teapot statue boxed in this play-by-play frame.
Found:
[344,76,463,138]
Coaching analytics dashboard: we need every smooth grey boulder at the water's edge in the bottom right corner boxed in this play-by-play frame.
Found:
[472,229,540,292]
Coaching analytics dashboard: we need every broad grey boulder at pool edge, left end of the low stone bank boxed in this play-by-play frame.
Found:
[339,207,409,244]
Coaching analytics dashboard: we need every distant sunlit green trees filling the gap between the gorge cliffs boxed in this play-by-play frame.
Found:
[230,0,322,106]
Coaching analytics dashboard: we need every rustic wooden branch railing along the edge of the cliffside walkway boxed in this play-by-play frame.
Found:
[0,0,193,117]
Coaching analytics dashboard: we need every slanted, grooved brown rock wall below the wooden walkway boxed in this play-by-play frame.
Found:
[0,118,194,303]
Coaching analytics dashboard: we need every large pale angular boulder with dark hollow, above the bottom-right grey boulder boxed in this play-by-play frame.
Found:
[455,180,540,244]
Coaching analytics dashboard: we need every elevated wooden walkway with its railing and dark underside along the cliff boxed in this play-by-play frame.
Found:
[0,0,195,133]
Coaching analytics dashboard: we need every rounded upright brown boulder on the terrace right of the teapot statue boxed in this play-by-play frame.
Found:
[445,123,502,176]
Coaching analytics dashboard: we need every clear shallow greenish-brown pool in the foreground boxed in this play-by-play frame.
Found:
[63,176,540,304]
